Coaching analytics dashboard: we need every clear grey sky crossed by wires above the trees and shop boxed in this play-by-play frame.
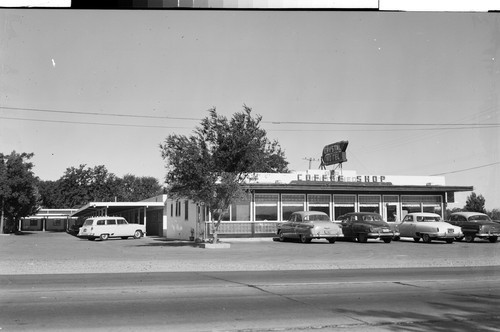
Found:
[0,9,500,210]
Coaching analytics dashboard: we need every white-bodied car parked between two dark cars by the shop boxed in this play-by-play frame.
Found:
[399,212,463,243]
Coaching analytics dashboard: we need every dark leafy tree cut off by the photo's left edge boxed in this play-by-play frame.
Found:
[0,151,39,233]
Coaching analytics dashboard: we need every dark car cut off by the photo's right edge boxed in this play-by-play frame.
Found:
[447,212,500,243]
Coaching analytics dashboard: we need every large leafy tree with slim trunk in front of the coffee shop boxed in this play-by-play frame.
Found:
[160,105,288,242]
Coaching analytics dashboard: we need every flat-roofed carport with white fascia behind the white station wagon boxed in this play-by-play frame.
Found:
[71,201,165,235]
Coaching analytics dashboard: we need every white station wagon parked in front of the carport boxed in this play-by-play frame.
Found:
[78,217,146,241]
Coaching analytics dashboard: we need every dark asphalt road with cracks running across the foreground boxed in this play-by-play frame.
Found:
[0,267,500,331]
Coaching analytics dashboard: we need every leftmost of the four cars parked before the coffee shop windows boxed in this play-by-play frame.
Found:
[277,211,343,243]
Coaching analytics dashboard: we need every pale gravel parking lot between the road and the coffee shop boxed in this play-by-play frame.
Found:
[0,232,500,274]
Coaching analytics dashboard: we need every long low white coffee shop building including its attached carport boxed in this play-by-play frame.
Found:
[67,170,473,240]
